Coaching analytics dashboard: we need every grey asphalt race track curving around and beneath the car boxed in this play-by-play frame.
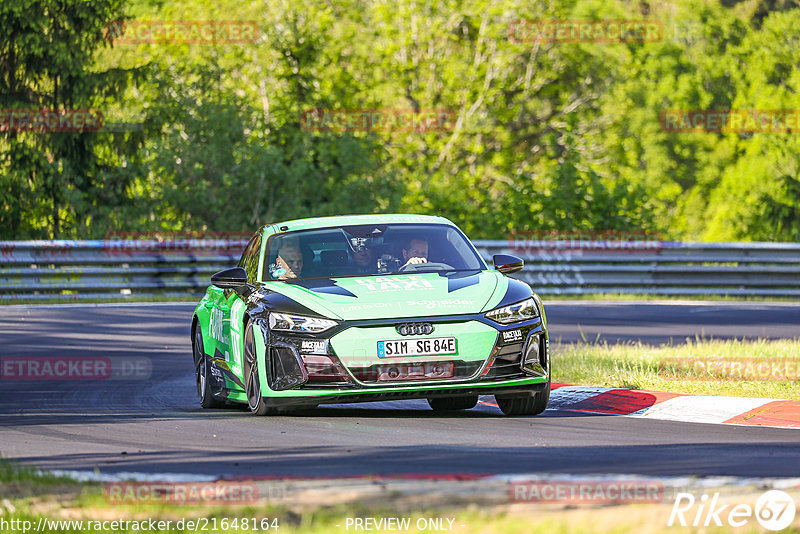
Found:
[0,302,800,477]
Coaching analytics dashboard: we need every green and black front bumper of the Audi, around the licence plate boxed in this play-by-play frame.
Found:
[260,315,550,406]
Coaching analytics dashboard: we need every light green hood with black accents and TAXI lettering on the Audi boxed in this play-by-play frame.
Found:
[264,271,508,321]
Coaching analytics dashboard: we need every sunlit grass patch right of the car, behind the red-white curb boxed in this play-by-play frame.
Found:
[552,339,800,400]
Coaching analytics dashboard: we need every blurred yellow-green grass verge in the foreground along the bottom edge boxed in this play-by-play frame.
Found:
[0,461,800,534]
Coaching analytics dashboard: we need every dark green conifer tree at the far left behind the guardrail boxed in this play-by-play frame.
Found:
[0,0,138,238]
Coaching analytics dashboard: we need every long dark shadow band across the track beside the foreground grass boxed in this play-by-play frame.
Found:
[18,441,800,477]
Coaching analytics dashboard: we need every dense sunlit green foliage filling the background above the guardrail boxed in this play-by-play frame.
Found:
[0,0,800,241]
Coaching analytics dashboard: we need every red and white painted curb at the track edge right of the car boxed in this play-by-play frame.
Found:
[524,384,800,428]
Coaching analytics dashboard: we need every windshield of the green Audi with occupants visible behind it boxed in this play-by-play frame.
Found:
[263,224,486,281]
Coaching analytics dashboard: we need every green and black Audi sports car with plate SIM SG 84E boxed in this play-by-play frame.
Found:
[192,215,550,415]
